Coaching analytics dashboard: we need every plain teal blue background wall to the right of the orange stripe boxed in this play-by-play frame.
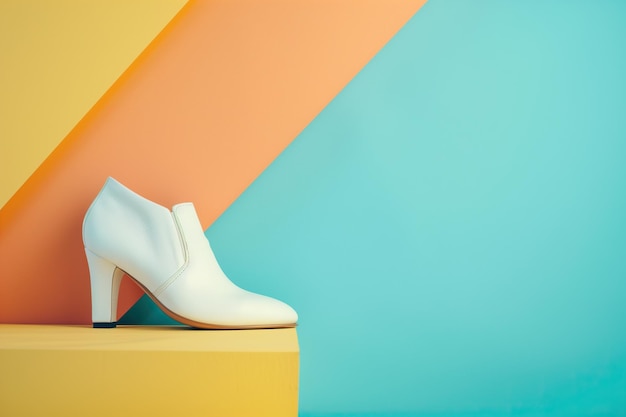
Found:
[120,0,626,416]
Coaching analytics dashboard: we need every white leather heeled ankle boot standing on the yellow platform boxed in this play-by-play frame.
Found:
[83,178,298,329]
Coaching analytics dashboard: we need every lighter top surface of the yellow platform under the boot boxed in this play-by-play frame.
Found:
[0,324,299,352]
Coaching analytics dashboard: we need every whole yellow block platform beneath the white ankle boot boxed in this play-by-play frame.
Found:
[0,324,299,417]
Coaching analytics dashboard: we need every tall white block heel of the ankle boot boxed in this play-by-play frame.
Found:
[85,248,124,329]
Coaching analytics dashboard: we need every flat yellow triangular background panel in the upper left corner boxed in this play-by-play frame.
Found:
[0,0,187,207]
